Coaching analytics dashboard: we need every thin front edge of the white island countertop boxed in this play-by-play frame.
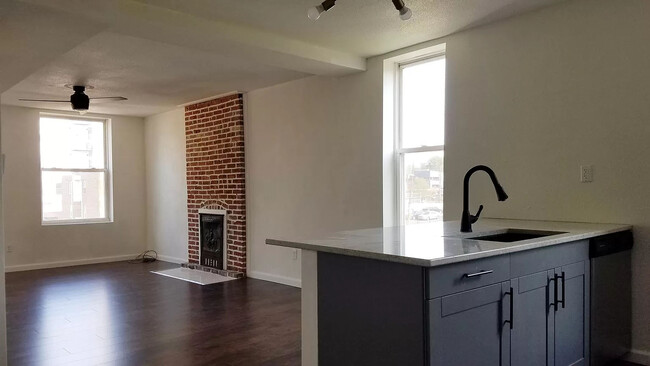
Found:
[266,225,633,267]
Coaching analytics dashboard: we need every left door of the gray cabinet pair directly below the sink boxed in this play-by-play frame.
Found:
[510,270,555,366]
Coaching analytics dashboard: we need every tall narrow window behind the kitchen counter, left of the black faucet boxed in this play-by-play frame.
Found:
[395,56,445,224]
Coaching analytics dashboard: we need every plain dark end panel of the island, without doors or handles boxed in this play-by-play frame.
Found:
[318,253,427,366]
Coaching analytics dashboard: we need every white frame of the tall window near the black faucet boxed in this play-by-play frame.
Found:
[393,50,447,226]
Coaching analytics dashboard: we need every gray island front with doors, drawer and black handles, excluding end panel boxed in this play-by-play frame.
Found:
[427,241,589,366]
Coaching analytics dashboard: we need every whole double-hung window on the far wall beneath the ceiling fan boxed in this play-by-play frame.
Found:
[40,115,111,224]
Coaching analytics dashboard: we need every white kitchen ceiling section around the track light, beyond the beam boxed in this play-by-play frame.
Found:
[135,0,564,57]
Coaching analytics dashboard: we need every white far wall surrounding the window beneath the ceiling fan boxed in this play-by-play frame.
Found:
[2,106,146,270]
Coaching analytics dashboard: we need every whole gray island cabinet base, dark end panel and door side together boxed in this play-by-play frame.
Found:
[318,237,589,366]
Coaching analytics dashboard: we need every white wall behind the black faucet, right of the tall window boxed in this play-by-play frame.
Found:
[445,0,650,351]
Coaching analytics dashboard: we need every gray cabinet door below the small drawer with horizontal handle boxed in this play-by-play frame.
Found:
[429,281,510,366]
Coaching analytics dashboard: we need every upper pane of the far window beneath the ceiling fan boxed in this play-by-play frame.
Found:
[40,117,104,169]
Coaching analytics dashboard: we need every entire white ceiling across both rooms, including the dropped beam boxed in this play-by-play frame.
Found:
[0,0,563,116]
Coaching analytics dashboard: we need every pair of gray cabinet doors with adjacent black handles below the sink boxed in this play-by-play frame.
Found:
[510,261,589,366]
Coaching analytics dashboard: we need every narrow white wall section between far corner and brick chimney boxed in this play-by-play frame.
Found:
[145,108,187,263]
